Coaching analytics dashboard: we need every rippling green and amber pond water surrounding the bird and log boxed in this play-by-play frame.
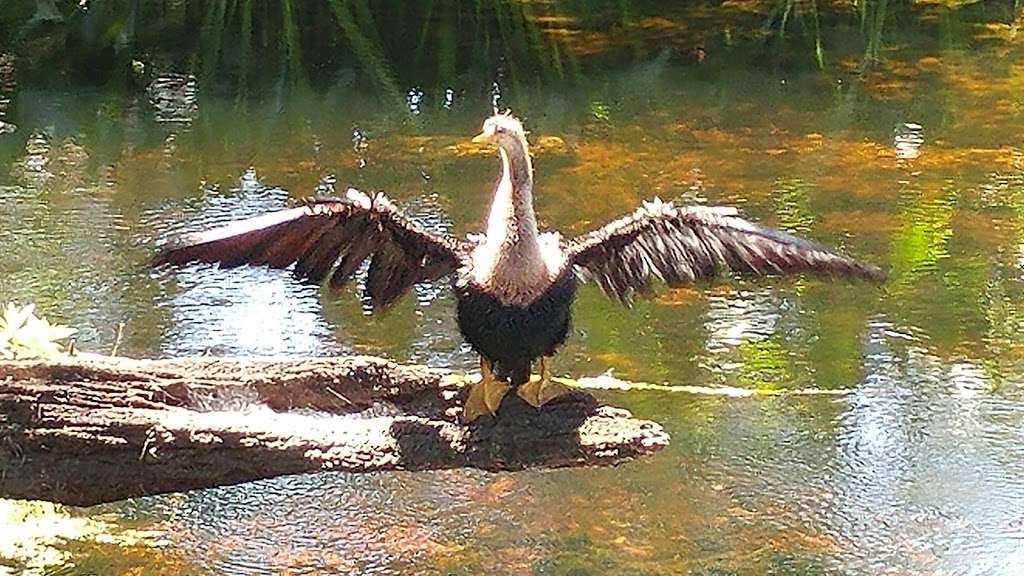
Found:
[0,0,1024,575]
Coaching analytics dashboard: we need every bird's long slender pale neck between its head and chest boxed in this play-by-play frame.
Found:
[487,141,537,243]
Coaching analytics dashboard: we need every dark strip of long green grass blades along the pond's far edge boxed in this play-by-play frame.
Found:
[6,0,1016,101]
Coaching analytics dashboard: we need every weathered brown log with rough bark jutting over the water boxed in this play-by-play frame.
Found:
[0,356,669,505]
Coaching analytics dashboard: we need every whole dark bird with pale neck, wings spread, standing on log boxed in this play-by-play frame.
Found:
[156,115,882,421]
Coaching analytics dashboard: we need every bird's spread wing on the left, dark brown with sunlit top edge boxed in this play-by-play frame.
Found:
[154,189,470,307]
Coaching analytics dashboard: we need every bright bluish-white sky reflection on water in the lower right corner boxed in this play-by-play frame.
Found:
[828,324,1024,574]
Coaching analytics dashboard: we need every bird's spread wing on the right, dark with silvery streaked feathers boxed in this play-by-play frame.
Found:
[566,199,885,304]
